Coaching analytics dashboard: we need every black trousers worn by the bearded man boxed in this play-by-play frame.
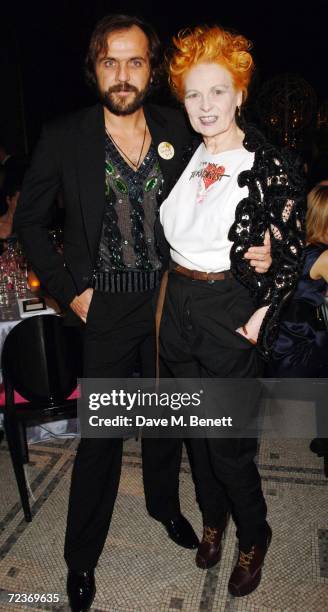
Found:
[64,291,182,571]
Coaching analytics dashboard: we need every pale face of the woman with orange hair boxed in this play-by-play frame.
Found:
[184,63,242,137]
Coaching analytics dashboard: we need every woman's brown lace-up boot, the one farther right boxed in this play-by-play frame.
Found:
[228,525,272,597]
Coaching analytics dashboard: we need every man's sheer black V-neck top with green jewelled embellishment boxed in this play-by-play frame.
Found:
[95,135,163,273]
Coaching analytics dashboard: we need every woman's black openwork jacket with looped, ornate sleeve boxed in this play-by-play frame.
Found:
[184,125,306,358]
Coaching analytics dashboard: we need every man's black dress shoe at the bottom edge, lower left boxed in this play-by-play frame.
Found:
[67,570,96,612]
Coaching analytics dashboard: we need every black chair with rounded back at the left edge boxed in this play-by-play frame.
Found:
[2,315,82,522]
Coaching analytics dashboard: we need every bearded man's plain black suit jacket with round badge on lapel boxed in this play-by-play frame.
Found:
[14,104,191,306]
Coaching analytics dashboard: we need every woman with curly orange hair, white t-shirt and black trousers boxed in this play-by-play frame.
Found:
[160,26,305,596]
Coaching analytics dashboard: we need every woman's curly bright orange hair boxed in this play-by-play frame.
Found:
[169,26,254,101]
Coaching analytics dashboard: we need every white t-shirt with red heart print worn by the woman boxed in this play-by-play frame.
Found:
[160,143,254,272]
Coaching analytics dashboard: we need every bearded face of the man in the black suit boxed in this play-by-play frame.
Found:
[95,26,151,115]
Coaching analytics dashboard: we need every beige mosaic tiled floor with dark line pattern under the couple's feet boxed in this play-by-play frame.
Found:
[0,440,328,612]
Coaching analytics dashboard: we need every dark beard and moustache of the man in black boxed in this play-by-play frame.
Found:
[98,81,150,116]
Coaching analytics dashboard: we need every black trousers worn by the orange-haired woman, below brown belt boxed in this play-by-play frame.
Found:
[160,272,266,548]
